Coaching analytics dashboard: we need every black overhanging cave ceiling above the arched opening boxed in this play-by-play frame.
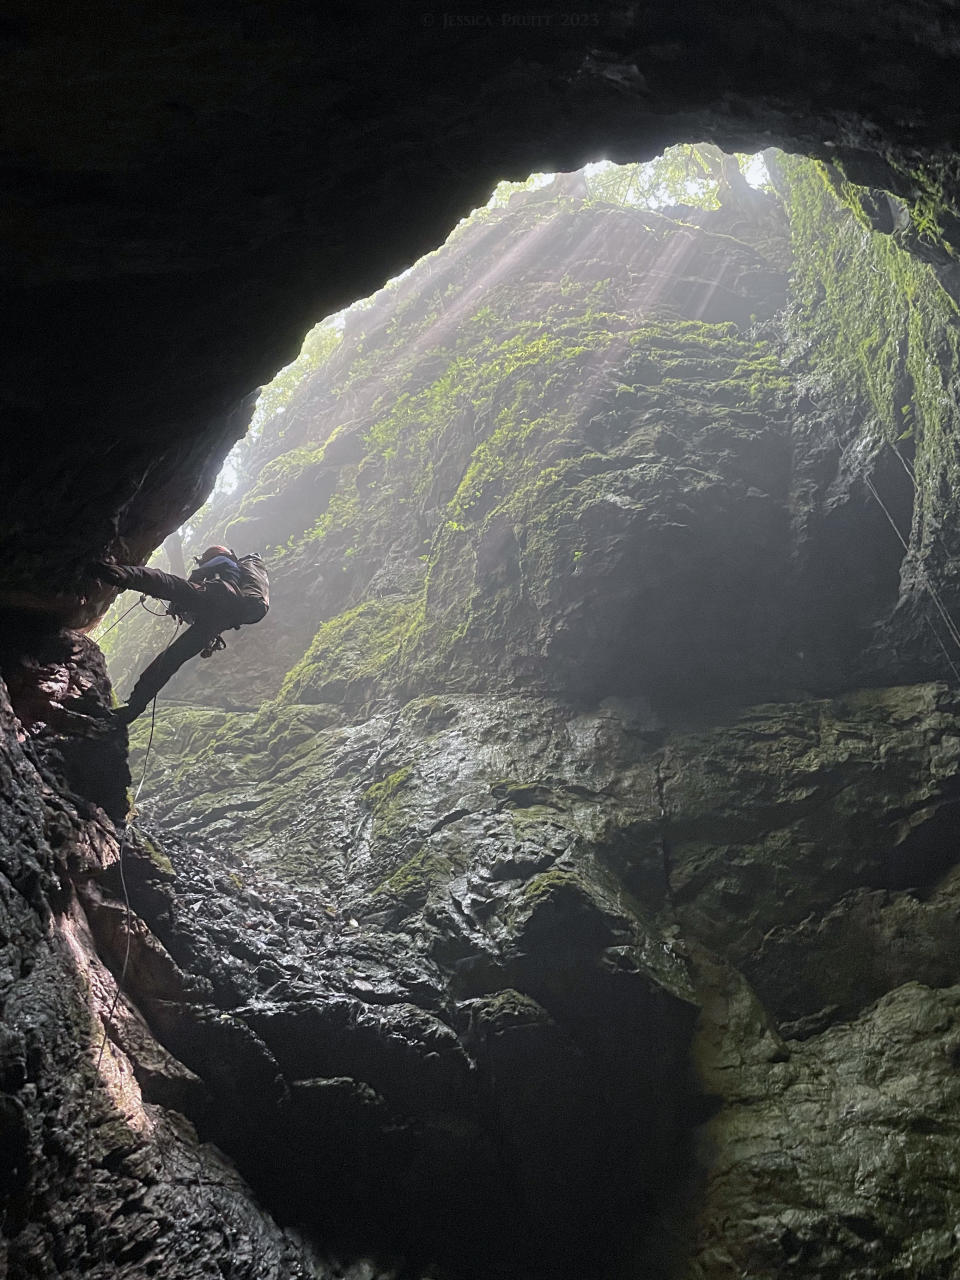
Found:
[0,0,960,609]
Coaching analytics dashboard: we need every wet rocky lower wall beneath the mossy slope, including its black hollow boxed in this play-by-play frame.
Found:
[101,686,960,1276]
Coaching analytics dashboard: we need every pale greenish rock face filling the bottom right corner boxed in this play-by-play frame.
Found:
[691,979,960,1277]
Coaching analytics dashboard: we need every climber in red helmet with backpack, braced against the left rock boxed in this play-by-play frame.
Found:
[90,547,270,724]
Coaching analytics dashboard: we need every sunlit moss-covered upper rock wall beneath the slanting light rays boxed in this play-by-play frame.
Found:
[110,151,786,727]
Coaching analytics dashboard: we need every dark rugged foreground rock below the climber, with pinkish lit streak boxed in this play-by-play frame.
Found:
[0,636,333,1280]
